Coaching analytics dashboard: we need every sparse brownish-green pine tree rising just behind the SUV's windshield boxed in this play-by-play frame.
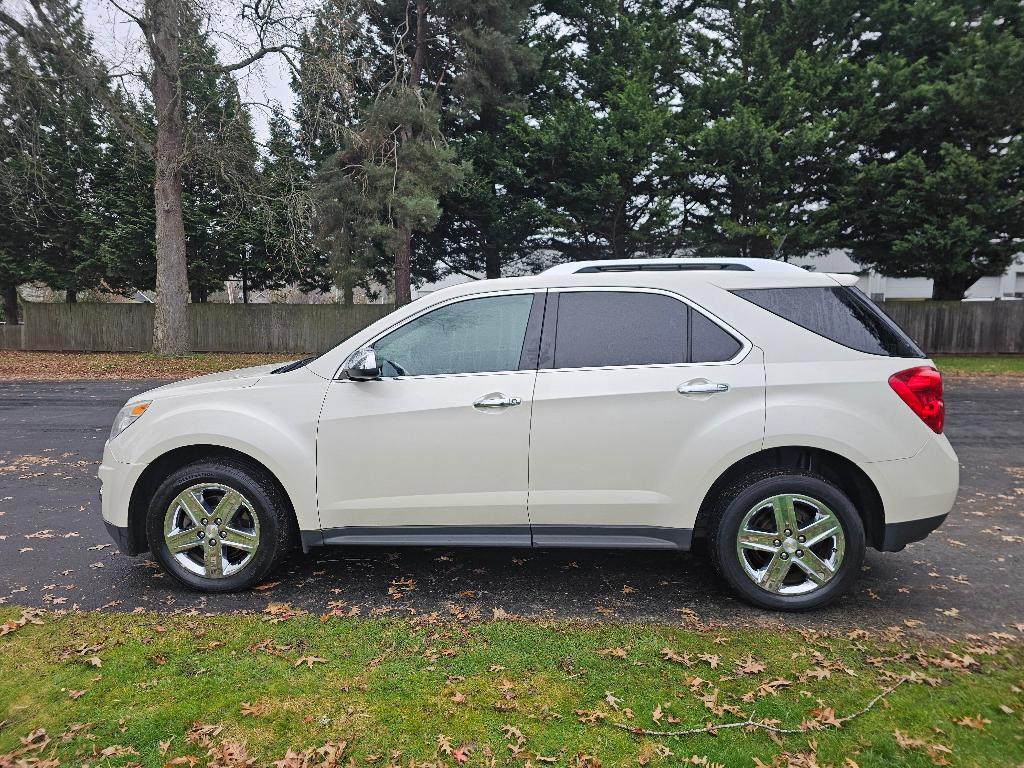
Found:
[304,0,473,305]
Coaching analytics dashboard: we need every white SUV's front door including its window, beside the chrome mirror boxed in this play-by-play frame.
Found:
[316,292,544,546]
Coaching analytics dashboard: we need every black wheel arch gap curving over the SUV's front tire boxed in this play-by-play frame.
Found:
[127,444,298,554]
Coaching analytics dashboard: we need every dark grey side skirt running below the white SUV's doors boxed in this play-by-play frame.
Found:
[302,525,693,552]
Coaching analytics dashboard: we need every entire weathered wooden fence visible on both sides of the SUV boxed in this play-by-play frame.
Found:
[0,301,1024,354]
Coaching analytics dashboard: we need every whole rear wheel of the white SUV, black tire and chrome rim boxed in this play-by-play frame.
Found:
[709,469,864,611]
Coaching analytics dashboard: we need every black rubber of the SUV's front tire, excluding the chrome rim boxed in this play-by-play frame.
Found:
[146,462,282,592]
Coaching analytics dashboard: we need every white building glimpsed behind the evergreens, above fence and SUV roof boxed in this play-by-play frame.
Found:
[413,248,1024,301]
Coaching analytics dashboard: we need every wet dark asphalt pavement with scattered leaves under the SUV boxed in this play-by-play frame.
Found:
[0,379,1024,635]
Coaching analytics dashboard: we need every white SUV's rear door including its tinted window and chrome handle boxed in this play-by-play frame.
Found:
[529,288,765,548]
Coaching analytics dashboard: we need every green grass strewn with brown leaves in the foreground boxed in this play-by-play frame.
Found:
[0,608,1024,768]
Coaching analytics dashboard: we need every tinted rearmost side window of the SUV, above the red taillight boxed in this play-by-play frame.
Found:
[733,286,925,357]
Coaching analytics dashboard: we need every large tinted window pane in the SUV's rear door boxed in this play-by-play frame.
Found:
[554,291,689,368]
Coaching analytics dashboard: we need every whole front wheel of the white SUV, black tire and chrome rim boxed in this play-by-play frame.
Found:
[146,459,296,592]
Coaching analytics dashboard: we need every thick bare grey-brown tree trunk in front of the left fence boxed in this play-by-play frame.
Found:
[146,0,188,354]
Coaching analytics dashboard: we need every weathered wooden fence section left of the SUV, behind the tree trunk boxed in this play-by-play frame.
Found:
[6,302,394,353]
